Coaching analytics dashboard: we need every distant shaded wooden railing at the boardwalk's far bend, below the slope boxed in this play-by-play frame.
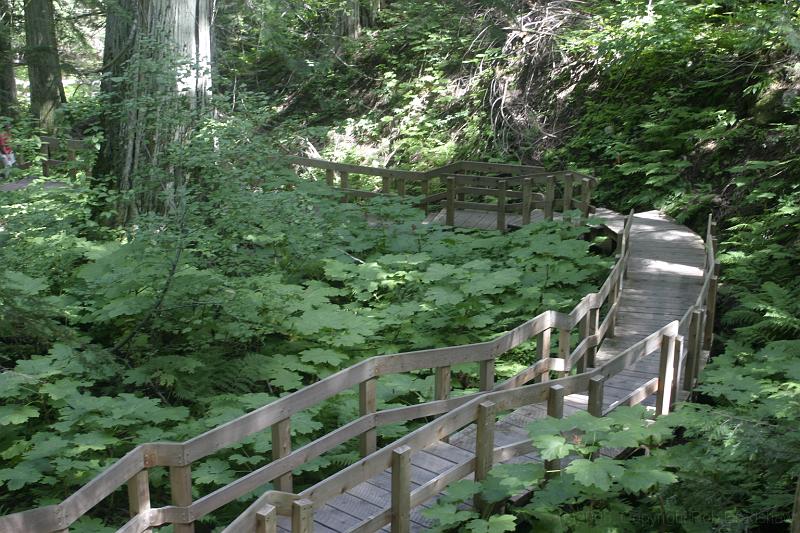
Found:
[287,157,597,231]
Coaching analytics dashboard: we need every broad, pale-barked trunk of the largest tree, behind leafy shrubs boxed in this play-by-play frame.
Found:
[94,0,213,224]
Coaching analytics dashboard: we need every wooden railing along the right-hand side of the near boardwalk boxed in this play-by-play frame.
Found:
[223,213,719,533]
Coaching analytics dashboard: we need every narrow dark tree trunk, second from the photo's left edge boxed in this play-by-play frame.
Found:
[25,0,64,131]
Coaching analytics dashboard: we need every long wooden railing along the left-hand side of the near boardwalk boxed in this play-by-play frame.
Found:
[0,213,633,533]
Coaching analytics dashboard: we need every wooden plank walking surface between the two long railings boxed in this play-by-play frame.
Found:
[234,209,706,532]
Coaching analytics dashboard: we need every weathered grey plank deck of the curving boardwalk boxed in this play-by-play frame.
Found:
[304,209,705,532]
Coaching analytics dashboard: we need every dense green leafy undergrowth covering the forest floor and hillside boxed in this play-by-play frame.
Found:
[0,0,800,532]
